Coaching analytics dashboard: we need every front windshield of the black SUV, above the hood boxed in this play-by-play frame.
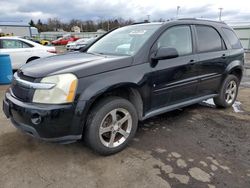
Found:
[87,24,161,55]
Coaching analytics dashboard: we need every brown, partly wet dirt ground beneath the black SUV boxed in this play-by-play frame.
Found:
[0,51,250,188]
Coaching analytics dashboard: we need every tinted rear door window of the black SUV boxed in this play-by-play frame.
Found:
[196,26,224,52]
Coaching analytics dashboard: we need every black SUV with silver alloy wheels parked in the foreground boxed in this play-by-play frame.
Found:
[3,19,244,155]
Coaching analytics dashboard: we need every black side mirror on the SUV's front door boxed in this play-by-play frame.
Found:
[152,47,179,60]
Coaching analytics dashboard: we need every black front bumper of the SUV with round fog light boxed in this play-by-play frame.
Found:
[3,92,84,143]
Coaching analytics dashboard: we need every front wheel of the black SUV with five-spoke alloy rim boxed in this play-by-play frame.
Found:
[84,97,138,155]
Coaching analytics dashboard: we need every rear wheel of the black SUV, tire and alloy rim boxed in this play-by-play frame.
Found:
[214,75,240,108]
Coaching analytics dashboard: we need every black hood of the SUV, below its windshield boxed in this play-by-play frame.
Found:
[20,52,133,78]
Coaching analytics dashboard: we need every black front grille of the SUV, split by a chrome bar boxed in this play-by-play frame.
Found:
[11,72,35,102]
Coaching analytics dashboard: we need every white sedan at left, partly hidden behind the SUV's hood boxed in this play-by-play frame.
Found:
[0,37,56,70]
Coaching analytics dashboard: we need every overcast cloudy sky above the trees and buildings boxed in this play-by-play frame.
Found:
[0,0,250,22]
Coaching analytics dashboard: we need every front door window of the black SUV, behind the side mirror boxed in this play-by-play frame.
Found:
[157,26,192,55]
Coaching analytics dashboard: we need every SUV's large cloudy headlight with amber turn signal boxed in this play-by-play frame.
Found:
[33,74,78,104]
